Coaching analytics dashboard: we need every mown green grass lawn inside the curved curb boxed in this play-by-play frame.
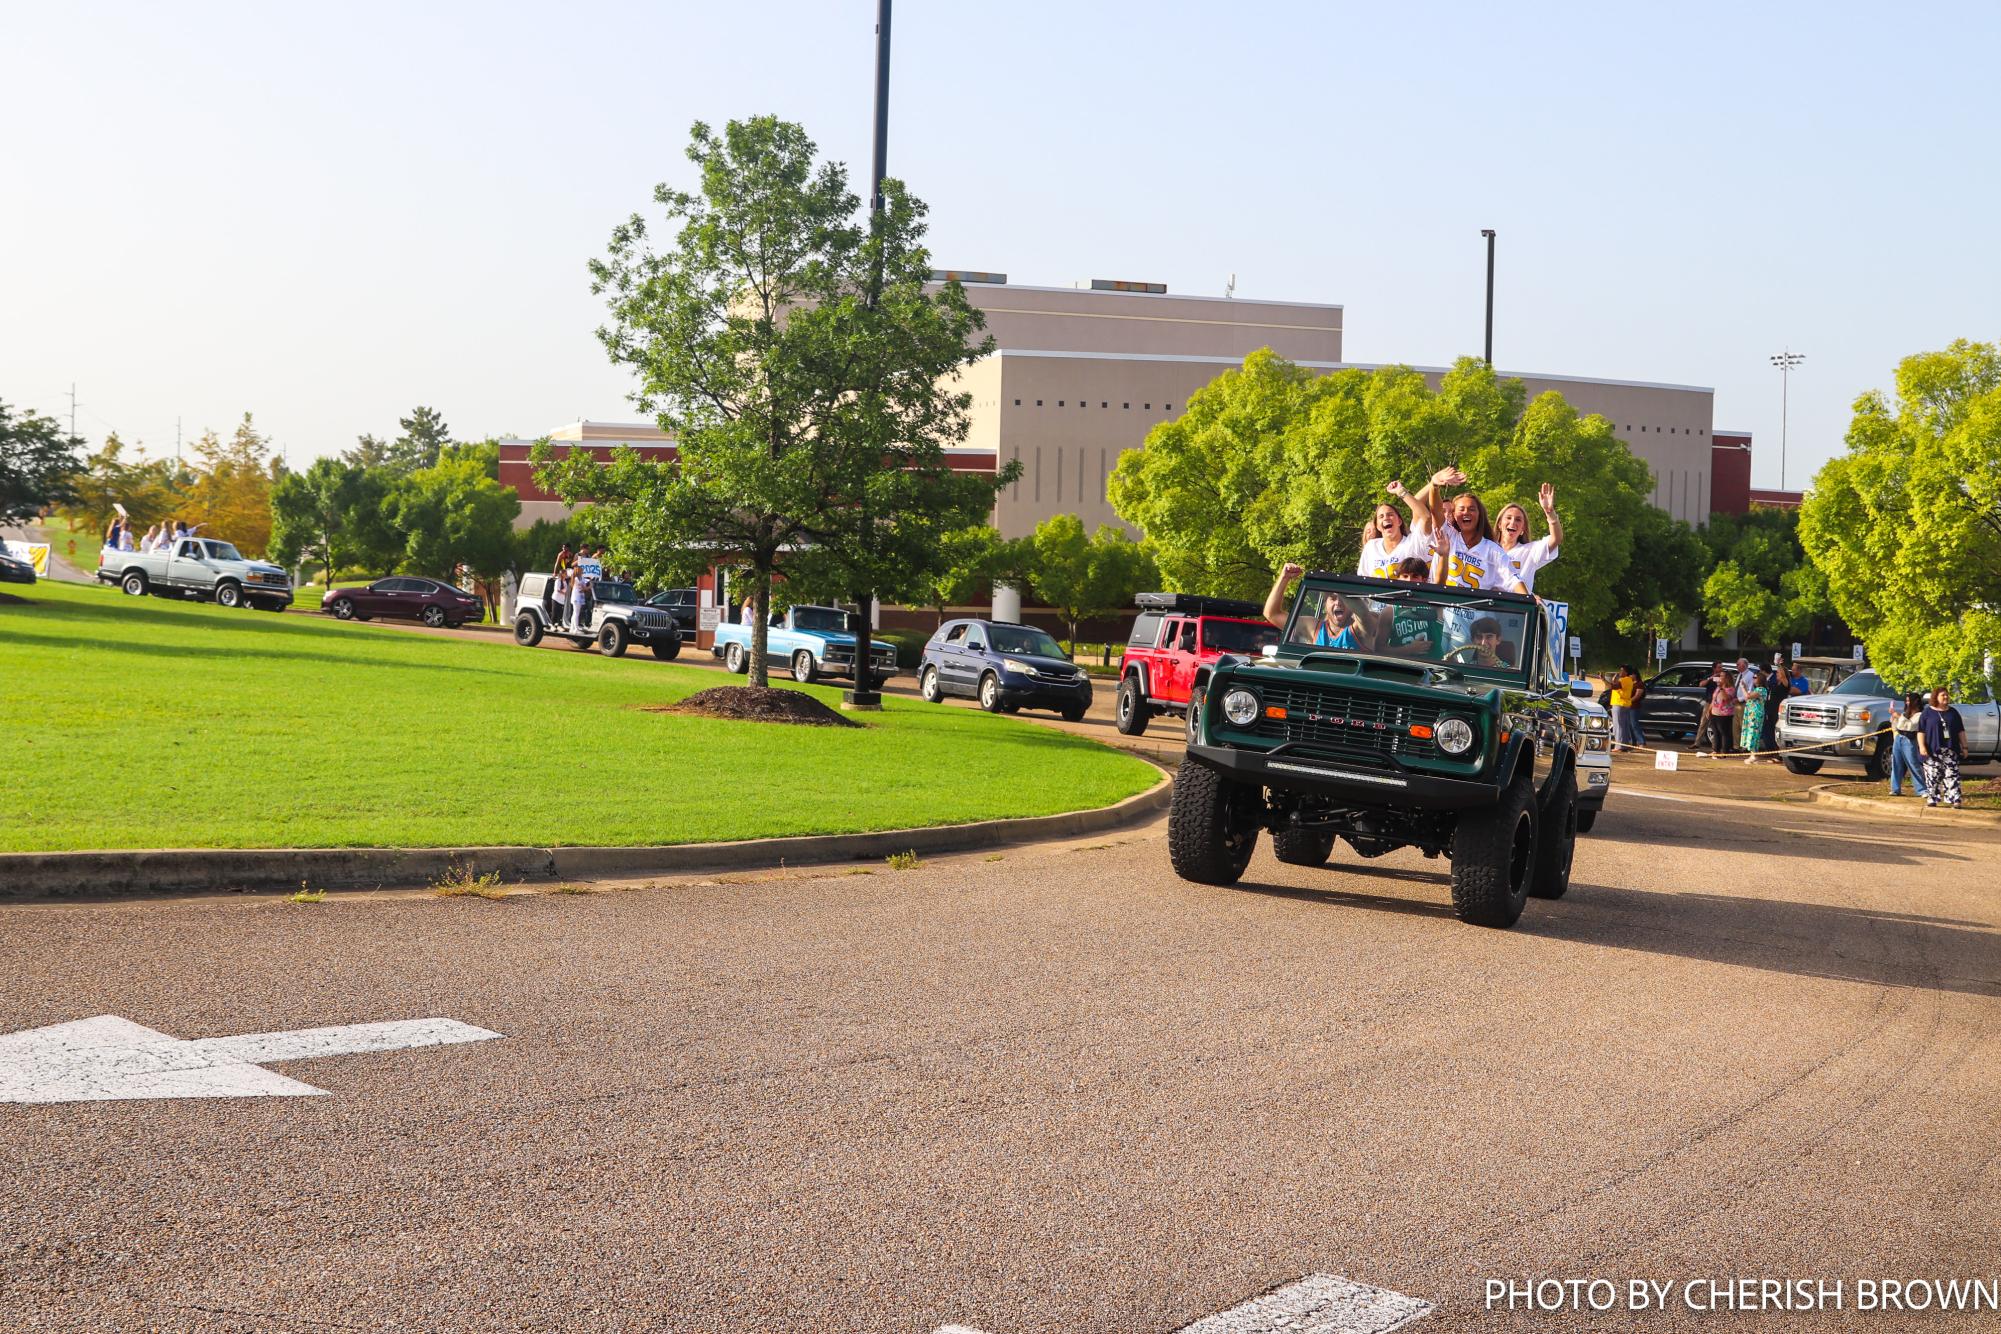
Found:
[0,582,1157,852]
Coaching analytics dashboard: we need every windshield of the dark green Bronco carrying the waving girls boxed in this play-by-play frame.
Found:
[1285,580,1535,678]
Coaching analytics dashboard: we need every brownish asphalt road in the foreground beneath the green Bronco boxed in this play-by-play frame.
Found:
[0,792,2001,1334]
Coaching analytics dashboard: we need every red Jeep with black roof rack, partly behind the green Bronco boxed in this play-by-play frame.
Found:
[1115,592,1279,736]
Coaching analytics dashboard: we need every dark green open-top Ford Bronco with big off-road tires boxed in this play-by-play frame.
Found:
[1169,574,1585,926]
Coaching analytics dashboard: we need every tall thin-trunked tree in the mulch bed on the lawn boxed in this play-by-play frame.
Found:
[532,116,992,686]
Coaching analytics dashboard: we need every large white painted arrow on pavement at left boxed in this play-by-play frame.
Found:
[0,1014,500,1102]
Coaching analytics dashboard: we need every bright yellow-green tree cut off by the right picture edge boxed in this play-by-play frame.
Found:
[1799,340,2001,688]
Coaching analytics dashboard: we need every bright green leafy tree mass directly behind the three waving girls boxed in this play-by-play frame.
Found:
[1109,350,1653,628]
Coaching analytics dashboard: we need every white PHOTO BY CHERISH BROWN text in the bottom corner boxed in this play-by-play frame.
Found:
[1483,1276,2001,1312]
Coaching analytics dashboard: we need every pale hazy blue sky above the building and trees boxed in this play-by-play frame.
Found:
[0,0,2001,486]
